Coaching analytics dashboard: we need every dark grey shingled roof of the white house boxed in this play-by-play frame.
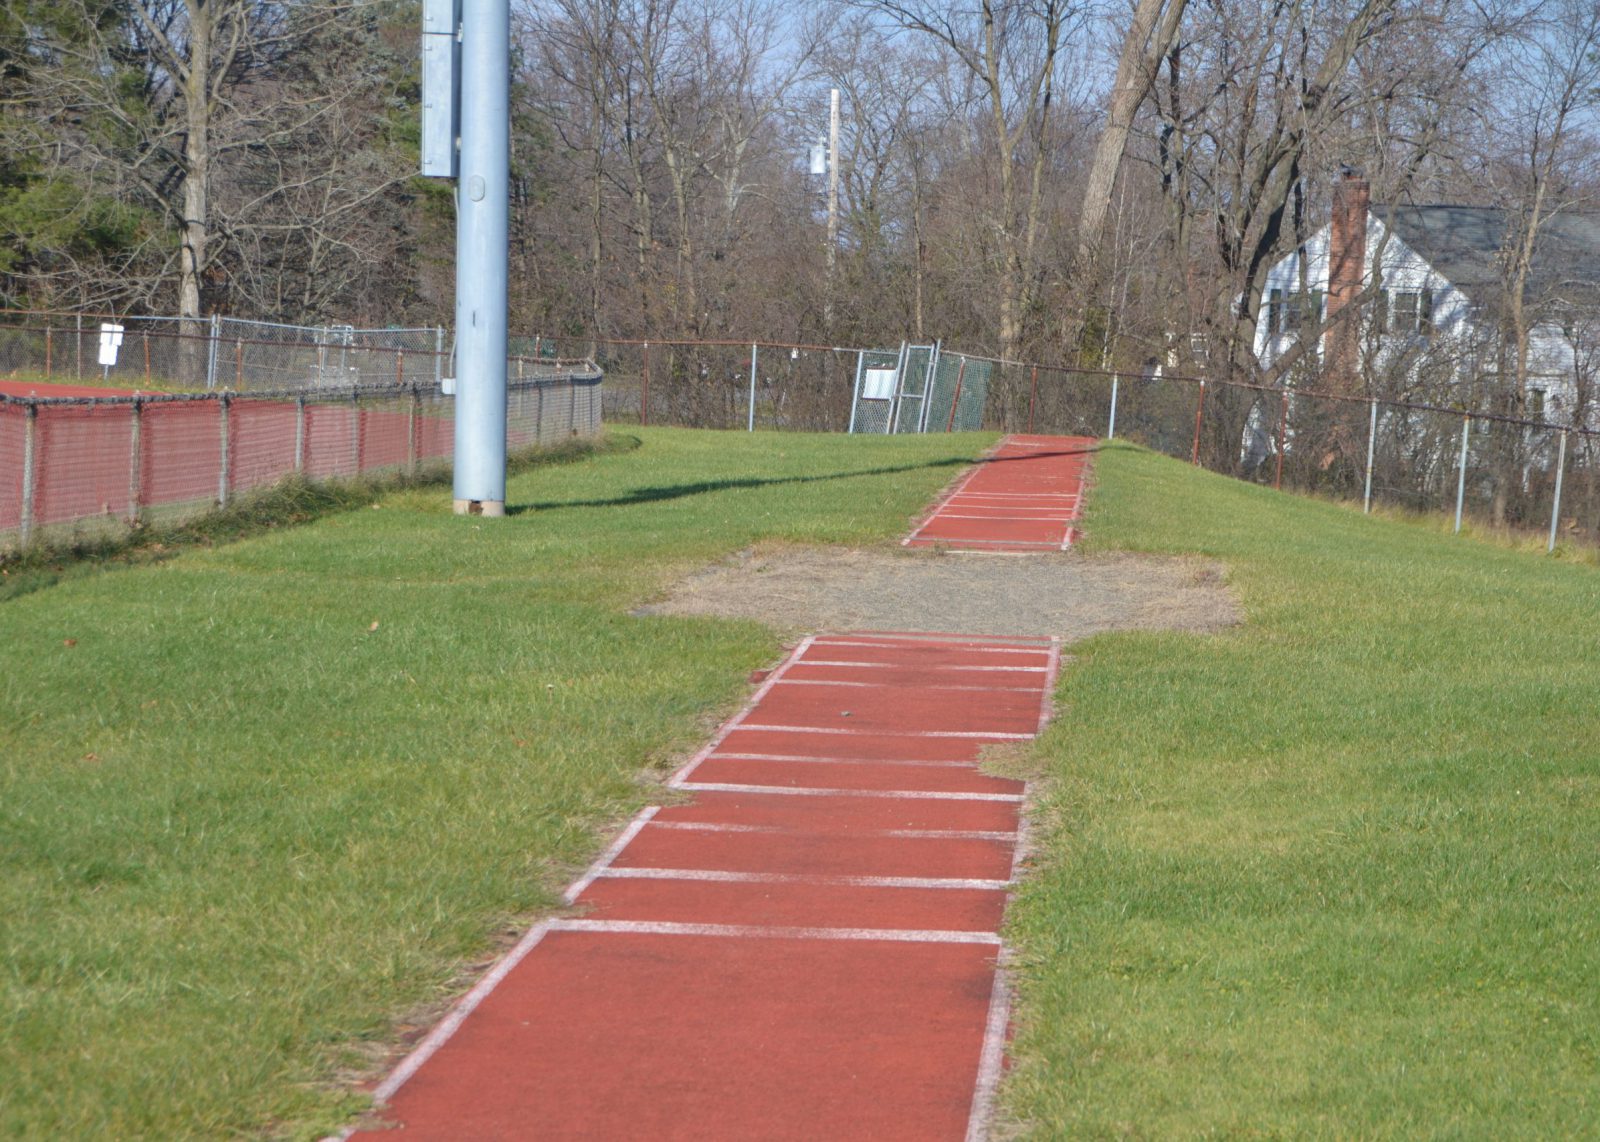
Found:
[1371,205,1600,305]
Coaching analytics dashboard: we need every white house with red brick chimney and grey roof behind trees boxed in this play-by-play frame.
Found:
[1256,174,1600,424]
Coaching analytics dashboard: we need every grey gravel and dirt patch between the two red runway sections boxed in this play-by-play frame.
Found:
[638,549,1240,640]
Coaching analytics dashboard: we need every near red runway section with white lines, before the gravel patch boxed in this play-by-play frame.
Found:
[347,633,1059,1142]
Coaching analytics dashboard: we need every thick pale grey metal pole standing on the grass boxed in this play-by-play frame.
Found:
[453,0,510,515]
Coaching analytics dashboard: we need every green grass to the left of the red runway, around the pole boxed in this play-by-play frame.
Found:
[0,430,990,1139]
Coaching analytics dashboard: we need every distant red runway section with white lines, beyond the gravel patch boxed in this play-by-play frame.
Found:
[904,437,1094,552]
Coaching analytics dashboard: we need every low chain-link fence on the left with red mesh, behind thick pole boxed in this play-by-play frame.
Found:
[0,345,602,550]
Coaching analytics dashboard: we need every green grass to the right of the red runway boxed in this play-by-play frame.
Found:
[1005,446,1600,1139]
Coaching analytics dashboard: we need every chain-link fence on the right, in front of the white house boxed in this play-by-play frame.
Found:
[1011,361,1600,549]
